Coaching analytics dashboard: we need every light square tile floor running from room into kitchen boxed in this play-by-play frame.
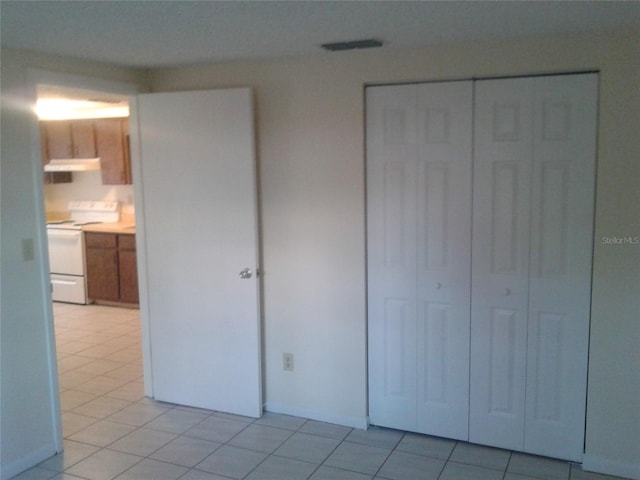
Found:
[14,303,628,480]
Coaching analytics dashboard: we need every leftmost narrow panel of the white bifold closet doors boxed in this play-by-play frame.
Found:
[367,86,417,430]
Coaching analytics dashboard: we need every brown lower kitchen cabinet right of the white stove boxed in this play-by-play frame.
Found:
[85,232,138,304]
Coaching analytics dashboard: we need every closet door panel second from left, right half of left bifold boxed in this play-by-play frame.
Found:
[417,82,473,440]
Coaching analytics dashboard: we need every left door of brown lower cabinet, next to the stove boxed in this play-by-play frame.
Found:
[85,233,120,301]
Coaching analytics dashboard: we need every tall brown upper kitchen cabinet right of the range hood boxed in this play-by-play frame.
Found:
[94,118,131,185]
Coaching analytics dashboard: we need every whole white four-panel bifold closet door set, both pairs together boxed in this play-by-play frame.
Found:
[366,74,597,461]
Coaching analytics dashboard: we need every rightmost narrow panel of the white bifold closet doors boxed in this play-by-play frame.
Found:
[525,74,597,461]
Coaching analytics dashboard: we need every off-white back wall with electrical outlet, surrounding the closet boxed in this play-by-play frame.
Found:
[151,32,640,478]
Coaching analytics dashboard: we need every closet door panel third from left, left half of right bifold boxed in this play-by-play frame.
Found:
[469,78,533,450]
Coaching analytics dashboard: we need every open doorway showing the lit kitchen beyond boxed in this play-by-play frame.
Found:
[36,82,144,438]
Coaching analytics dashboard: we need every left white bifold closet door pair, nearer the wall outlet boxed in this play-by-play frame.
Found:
[367,81,472,439]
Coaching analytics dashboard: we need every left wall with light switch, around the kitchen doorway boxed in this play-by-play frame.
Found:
[0,49,144,480]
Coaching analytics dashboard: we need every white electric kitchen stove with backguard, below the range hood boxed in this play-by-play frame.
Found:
[47,201,120,305]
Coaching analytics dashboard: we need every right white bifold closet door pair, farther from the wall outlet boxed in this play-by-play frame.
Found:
[469,74,597,461]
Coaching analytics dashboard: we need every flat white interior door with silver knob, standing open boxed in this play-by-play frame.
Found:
[138,89,262,417]
